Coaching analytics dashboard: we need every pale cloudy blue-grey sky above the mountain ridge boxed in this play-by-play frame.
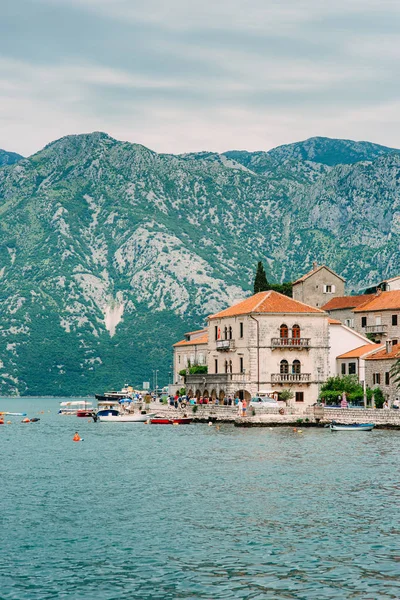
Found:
[0,0,400,156]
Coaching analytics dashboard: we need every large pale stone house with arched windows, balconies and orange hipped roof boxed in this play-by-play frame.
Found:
[186,290,329,407]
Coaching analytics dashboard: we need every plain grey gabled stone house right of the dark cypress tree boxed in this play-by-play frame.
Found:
[293,263,345,308]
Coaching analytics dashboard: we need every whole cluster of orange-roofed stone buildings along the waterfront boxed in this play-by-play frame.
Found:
[173,263,400,408]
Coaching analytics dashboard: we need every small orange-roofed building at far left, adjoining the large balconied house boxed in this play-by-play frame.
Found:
[173,329,208,385]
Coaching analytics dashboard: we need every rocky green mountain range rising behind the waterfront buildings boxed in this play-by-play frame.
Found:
[0,132,400,395]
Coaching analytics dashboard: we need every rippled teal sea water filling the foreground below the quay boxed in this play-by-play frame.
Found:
[0,399,400,600]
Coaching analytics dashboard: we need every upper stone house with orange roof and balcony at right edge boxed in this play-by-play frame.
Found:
[353,290,400,342]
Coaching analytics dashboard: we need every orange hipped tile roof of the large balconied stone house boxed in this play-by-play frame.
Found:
[208,290,324,319]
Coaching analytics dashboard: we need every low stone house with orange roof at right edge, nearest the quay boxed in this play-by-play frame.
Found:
[365,340,400,406]
